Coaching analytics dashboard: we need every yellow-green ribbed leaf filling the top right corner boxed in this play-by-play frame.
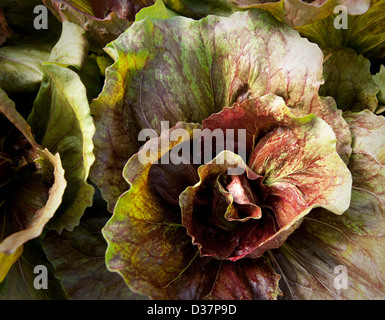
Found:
[297,0,385,60]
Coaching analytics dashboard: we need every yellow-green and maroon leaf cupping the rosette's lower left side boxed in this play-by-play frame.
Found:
[103,123,280,299]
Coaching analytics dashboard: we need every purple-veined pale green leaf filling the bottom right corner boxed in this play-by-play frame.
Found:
[273,110,385,299]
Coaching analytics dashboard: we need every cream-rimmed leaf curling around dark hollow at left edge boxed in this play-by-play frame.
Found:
[0,89,67,282]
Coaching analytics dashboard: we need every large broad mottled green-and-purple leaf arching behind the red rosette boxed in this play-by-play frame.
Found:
[91,10,351,211]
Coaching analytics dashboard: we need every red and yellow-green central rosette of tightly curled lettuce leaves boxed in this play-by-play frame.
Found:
[104,94,352,299]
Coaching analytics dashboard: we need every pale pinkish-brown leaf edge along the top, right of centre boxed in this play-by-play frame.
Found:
[228,0,370,27]
